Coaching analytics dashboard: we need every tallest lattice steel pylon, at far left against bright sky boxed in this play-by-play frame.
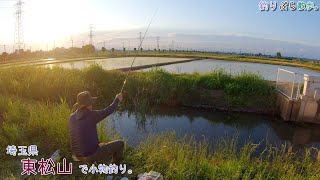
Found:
[13,0,24,53]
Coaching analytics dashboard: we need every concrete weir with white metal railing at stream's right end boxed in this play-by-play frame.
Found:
[276,69,320,124]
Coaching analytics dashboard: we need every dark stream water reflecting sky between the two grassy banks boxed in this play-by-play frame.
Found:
[107,109,320,153]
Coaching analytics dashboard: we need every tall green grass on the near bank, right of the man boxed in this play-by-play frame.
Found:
[128,133,320,179]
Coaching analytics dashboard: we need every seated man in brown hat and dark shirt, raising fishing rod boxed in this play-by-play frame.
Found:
[69,91,124,164]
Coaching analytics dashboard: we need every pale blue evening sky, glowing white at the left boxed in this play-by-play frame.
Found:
[0,0,320,60]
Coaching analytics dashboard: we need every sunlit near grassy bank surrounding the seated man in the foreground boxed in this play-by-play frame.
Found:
[0,95,320,180]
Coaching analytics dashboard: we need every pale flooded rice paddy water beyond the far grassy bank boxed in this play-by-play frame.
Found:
[45,57,320,81]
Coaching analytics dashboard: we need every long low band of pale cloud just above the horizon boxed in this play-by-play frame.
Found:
[4,29,320,60]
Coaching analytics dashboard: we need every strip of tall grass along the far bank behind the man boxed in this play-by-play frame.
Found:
[0,66,273,109]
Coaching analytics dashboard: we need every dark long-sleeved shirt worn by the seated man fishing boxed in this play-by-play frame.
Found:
[69,98,119,157]
